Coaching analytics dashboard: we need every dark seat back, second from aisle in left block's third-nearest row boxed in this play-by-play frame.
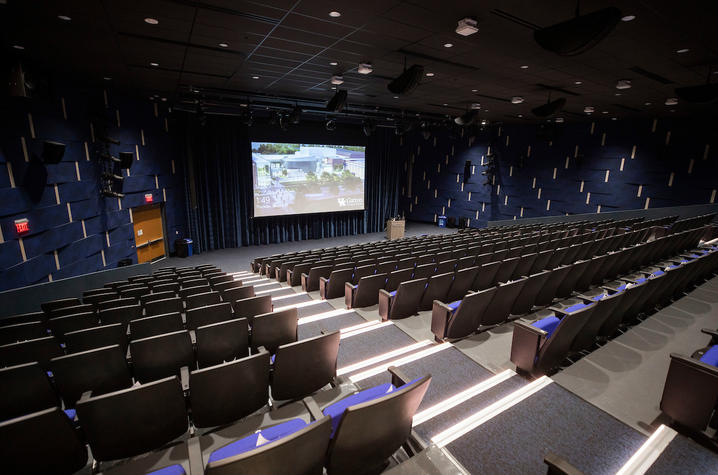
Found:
[195,318,249,368]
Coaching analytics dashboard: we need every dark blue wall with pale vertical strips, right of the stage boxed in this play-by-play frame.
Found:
[397,119,718,227]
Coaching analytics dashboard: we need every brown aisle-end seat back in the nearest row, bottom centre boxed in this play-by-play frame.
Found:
[326,376,431,474]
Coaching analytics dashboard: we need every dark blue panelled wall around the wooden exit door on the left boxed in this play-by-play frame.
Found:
[0,87,185,290]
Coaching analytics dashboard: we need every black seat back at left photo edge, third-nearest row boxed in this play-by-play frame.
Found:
[0,361,59,422]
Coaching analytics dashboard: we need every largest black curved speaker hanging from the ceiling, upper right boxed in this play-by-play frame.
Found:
[534,7,622,56]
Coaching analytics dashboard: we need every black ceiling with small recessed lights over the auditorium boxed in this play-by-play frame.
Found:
[0,0,718,121]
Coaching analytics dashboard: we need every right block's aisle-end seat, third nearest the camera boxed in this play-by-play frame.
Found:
[431,287,496,342]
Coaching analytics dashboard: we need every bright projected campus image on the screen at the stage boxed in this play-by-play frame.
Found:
[252,142,364,217]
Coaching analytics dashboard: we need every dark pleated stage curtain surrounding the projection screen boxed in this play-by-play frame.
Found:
[182,114,399,252]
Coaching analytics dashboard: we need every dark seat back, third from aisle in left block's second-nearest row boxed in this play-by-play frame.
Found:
[77,376,188,461]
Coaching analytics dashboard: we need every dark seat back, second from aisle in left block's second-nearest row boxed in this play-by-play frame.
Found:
[190,352,270,427]
